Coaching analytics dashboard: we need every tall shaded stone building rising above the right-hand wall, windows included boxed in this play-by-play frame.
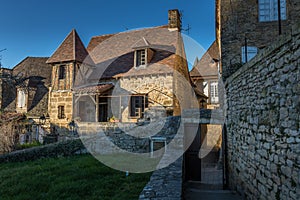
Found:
[216,0,300,80]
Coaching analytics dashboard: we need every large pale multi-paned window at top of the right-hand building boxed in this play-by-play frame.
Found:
[259,0,286,22]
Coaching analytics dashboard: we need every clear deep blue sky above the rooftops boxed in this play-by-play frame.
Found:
[0,0,215,68]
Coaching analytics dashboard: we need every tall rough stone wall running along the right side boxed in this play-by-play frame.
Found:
[226,26,300,200]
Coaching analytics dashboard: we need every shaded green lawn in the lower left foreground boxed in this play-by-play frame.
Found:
[0,155,151,200]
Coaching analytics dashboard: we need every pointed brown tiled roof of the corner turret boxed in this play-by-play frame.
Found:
[47,29,90,63]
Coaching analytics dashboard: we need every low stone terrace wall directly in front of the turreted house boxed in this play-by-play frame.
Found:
[77,117,180,153]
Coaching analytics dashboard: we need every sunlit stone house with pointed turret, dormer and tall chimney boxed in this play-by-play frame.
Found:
[47,10,206,130]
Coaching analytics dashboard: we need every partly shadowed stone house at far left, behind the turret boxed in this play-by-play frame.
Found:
[0,57,52,120]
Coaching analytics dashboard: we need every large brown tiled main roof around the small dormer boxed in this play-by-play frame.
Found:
[83,26,188,80]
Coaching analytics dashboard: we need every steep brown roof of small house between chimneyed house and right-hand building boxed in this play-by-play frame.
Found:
[190,41,220,77]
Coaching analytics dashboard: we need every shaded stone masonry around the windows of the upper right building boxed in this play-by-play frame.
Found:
[216,0,300,80]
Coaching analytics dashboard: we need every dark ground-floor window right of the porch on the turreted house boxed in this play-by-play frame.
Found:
[130,96,148,118]
